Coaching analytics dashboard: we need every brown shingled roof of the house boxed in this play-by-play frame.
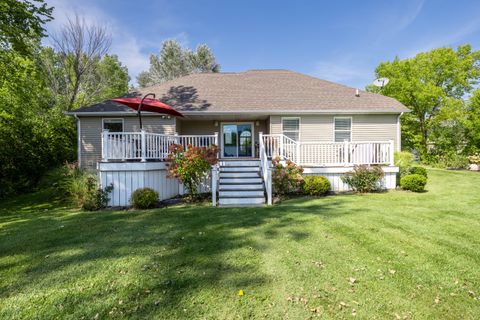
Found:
[71,70,408,114]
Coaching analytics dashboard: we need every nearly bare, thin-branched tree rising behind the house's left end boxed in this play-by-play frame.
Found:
[51,14,111,110]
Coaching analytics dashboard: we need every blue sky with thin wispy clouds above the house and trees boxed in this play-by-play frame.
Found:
[47,0,480,88]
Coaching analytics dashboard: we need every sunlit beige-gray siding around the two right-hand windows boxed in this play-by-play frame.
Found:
[270,114,398,147]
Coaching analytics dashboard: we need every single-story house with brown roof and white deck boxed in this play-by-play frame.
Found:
[69,70,408,205]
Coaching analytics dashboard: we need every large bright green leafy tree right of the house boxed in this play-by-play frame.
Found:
[367,45,480,157]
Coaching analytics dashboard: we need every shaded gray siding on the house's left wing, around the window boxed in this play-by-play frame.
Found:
[80,116,175,170]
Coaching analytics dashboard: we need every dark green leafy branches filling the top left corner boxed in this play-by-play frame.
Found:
[0,0,53,55]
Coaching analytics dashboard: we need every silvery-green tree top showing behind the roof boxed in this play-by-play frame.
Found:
[137,40,220,88]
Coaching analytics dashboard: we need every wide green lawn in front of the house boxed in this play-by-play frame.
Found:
[0,169,480,319]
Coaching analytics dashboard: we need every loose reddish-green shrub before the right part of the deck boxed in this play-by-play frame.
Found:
[342,165,384,193]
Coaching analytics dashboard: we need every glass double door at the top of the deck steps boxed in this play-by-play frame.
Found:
[222,123,253,158]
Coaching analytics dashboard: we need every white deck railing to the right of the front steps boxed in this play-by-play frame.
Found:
[261,134,394,166]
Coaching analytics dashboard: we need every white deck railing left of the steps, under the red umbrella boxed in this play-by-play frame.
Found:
[102,130,218,161]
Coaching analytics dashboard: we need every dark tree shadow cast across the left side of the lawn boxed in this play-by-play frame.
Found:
[0,192,360,316]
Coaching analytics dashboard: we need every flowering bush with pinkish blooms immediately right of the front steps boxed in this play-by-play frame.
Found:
[272,157,303,195]
